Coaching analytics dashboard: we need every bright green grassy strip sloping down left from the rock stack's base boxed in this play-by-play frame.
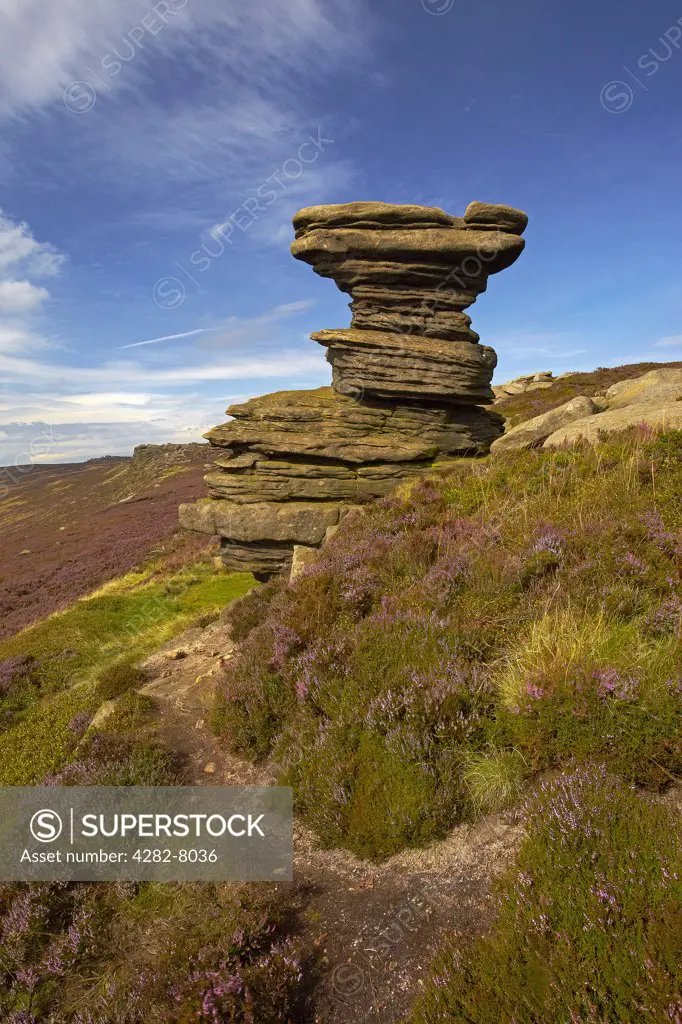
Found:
[0,563,253,785]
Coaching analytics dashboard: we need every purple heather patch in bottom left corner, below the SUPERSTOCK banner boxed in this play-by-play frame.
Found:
[0,882,301,1024]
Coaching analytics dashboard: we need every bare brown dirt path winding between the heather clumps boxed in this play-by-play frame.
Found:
[137,622,521,1024]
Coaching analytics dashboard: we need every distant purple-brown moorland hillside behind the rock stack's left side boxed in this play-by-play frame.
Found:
[0,444,208,638]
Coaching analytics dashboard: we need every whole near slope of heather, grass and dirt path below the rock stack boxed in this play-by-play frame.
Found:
[0,378,682,1024]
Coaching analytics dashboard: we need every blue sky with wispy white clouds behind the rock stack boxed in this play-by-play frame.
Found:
[0,0,682,466]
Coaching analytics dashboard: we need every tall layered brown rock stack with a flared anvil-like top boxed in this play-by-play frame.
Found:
[180,203,527,578]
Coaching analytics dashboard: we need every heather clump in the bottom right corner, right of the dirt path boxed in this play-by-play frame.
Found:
[411,766,682,1024]
